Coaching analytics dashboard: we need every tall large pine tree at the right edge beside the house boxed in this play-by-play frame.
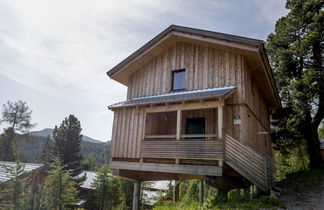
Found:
[267,0,324,169]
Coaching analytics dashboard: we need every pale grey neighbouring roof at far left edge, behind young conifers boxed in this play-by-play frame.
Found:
[0,161,44,183]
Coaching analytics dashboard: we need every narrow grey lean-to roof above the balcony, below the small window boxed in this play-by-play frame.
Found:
[109,86,236,108]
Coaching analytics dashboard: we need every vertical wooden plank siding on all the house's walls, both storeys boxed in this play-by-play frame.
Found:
[112,42,272,158]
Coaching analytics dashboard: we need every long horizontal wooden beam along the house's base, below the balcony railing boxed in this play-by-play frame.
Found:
[109,161,223,176]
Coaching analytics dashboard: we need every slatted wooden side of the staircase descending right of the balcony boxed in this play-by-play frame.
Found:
[224,133,275,193]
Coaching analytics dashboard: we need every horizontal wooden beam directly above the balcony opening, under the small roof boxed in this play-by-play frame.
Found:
[146,100,225,113]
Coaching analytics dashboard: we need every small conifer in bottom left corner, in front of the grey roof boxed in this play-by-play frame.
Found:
[0,161,25,210]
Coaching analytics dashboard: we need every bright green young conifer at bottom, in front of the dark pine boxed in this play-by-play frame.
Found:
[43,157,77,210]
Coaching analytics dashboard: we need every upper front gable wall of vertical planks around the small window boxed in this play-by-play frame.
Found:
[127,42,244,98]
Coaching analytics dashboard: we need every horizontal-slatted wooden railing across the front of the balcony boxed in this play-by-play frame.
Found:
[141,134,223,160]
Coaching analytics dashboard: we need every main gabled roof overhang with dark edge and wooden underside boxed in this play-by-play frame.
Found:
[107,25,281,107]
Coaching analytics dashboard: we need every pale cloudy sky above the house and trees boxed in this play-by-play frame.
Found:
[0,0,288,141]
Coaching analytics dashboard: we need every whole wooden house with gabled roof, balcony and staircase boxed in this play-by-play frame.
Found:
[107,25,281,200]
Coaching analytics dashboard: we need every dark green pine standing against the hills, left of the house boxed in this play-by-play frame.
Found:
[53,115,82,177]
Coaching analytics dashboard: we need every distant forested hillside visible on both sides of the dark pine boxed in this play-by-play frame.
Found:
[17,129,110,164]
